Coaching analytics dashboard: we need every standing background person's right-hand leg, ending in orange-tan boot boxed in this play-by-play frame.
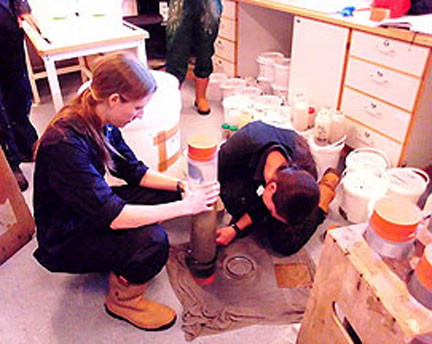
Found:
[193,0,222,115]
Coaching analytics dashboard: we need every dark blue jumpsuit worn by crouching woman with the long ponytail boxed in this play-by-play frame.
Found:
[33,118,181,283]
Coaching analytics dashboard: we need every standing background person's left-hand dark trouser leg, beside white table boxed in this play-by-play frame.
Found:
[166,0,193,85]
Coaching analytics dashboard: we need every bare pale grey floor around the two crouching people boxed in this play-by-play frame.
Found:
[0,74,341,344]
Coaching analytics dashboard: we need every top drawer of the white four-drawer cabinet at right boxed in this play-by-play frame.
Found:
[350,30,428,76]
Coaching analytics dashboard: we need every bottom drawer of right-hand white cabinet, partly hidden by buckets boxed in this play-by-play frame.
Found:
[346,119,402,166]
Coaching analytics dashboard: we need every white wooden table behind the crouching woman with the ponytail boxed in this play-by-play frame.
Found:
[23,21,149,111]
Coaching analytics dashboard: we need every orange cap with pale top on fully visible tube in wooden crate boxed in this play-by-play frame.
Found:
[370,197,422,242]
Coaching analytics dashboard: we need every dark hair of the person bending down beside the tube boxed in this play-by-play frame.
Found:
[273,165,320,225]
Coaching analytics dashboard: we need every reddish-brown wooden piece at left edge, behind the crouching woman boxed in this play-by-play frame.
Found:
[0,148,35,265]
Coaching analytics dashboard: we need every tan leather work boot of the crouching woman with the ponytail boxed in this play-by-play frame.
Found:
[105,272,177,331]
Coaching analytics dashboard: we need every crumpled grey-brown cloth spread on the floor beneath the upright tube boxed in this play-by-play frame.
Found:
[167,236,315,340]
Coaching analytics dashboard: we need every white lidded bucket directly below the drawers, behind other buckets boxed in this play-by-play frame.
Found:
[345,147,391,176]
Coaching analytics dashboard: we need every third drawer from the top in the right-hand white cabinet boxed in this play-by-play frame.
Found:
[341,87,410,143]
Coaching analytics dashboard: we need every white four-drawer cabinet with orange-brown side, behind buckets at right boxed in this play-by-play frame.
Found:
[341,30,432,168]
